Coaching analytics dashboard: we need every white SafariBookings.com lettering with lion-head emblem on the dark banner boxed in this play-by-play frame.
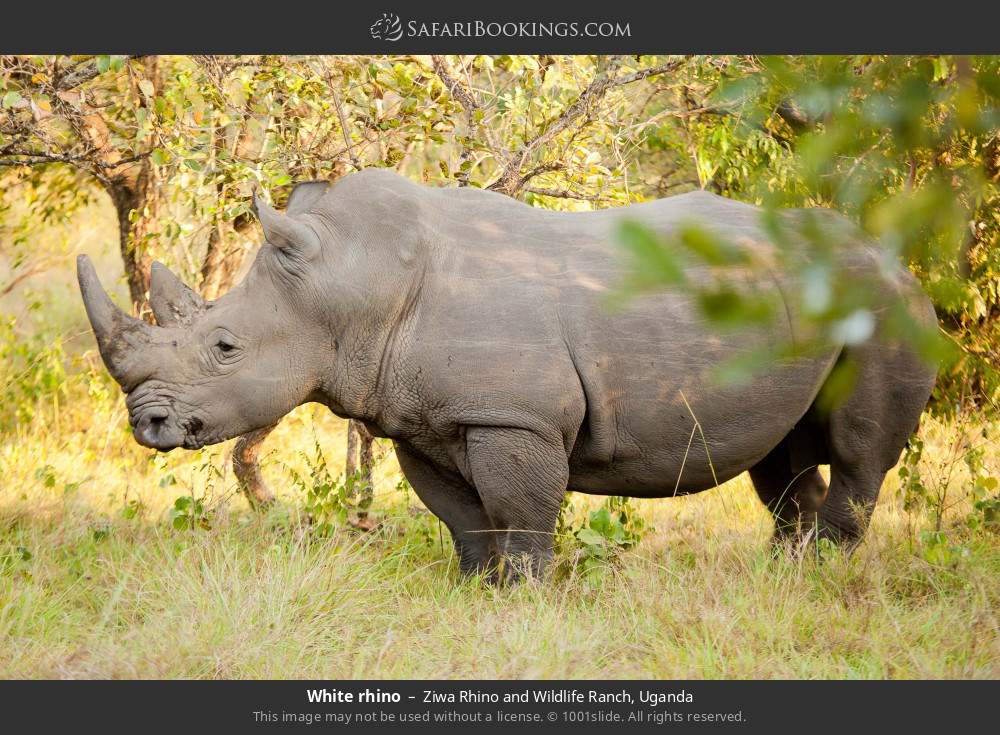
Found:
[369,13,632,41]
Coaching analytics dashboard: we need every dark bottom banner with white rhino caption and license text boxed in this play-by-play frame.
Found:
[0,681,1000,733]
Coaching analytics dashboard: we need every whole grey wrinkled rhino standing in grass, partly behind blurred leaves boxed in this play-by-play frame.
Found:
[79,170,935,576]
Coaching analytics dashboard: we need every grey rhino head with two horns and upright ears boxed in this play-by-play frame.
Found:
[77,184,346,451]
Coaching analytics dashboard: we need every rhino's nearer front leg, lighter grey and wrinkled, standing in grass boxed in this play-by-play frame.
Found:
[466,427,569,582]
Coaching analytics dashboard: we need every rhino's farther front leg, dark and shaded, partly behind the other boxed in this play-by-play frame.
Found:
[395,442,498,581]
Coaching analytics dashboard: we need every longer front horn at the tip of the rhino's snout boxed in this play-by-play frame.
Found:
[76,255,153,387]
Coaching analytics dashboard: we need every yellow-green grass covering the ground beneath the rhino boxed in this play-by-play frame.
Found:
[0,394,1000,678]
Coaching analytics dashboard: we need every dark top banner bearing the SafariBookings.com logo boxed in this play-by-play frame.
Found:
[0,0,1000,54]
